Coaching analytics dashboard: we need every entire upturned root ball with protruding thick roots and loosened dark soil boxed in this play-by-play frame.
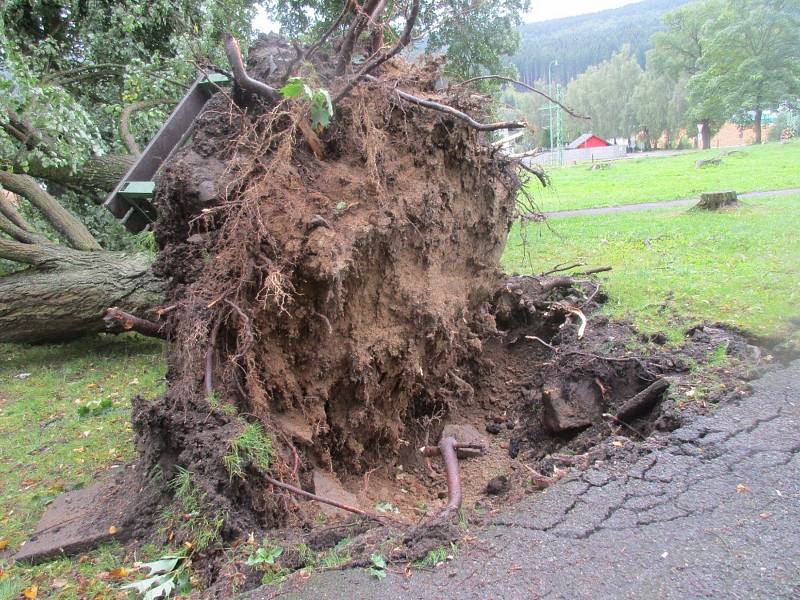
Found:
[17,0,688,597]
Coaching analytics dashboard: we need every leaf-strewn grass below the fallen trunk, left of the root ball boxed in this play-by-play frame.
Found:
[0,335,165,600]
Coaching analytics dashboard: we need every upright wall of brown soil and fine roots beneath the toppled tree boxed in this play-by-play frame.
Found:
[134,38,519,535]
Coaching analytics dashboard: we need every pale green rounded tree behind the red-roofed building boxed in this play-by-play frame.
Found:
[565,46,643,138]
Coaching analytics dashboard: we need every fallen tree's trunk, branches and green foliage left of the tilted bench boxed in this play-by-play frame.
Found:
[0,0,262,341]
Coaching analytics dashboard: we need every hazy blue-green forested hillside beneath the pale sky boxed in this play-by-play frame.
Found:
[513,0,689,83]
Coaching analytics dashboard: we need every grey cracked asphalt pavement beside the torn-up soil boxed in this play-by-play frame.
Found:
[249,361,800,600]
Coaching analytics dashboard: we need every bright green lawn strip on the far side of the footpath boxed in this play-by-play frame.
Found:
[531,141,800,212]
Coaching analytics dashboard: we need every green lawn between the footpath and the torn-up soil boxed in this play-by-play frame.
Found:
[503,192,800,341]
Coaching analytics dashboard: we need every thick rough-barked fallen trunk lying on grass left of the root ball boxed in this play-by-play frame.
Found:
[0,245,162,342]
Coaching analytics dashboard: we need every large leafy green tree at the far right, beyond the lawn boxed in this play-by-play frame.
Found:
[648,0,800,141]
